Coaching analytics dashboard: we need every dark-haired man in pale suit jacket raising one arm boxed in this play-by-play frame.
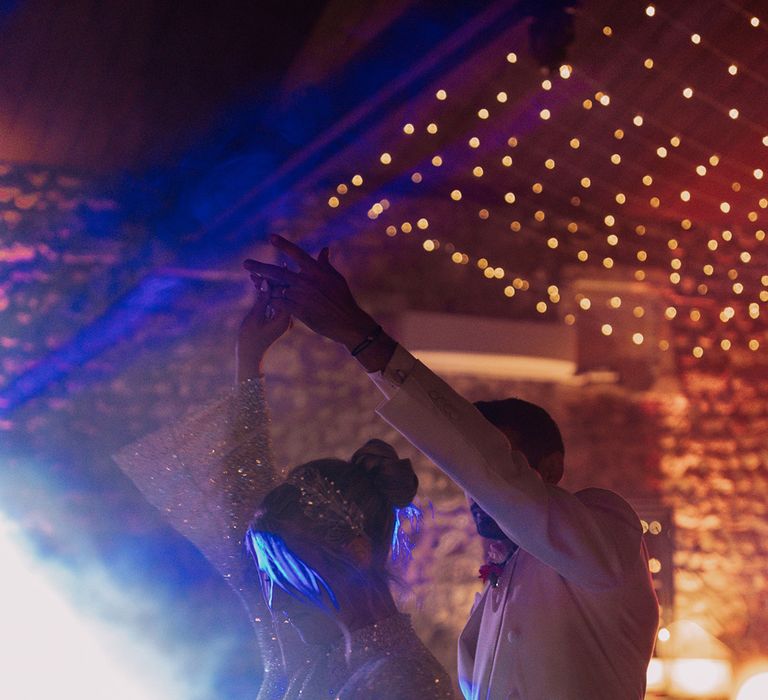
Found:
[244,236,658,700]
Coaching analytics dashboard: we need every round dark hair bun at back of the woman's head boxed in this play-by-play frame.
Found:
[350,439,419,508]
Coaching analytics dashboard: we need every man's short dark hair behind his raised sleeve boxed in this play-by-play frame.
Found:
[475,398,565,469]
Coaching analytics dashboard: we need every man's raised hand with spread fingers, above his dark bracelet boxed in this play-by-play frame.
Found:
[243,236,377,352]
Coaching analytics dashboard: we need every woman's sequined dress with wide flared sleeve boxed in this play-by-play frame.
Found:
[114,379,454,700]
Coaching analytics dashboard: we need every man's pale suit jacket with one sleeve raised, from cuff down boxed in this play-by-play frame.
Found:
[370,347,658,700]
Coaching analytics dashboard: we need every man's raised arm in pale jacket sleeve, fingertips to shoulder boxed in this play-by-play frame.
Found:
[244,236,640,588]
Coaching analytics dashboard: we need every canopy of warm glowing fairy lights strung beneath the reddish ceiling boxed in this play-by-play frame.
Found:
[318,3,768,358]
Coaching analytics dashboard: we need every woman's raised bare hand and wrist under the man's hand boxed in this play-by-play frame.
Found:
[237,275,291,382]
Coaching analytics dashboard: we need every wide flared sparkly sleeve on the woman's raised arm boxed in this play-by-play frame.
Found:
[109,379,275,589]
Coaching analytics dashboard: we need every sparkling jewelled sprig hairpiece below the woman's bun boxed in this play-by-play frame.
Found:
[286,468,365,543]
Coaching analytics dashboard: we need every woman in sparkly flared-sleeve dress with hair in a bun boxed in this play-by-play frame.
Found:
[115,277,453,700]
